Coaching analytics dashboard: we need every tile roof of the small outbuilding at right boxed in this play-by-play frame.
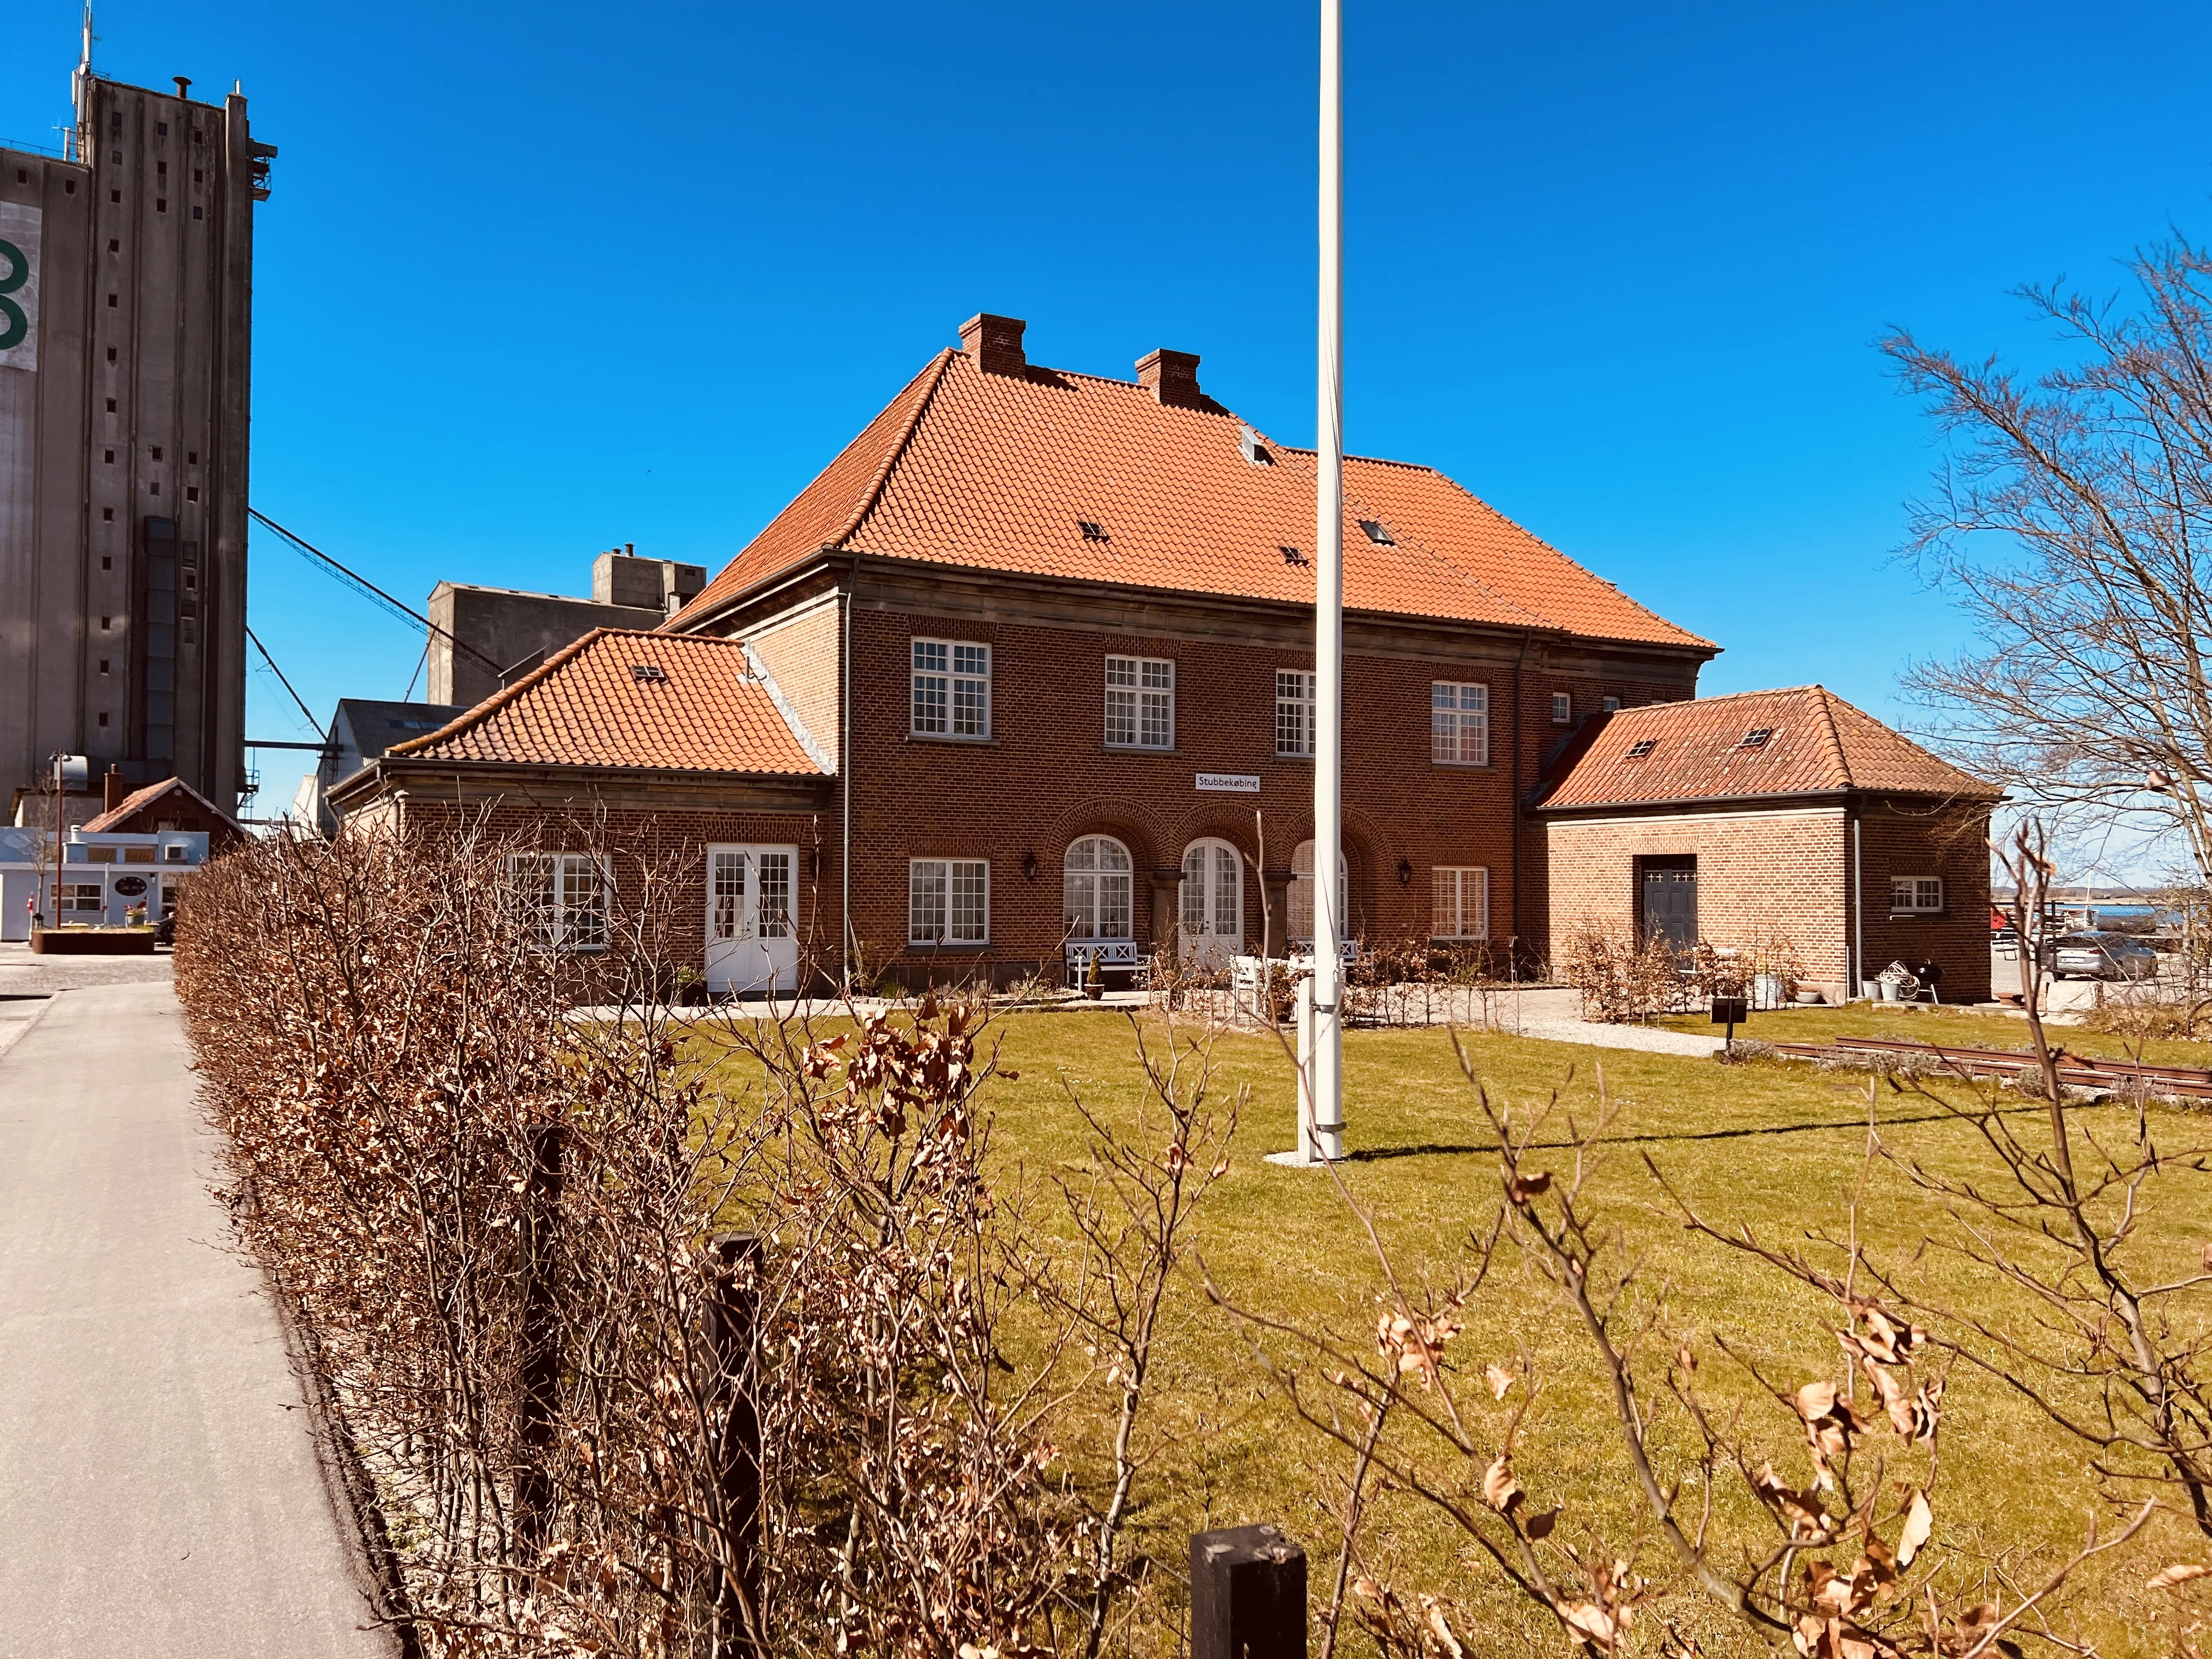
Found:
[1539,686,2002,812]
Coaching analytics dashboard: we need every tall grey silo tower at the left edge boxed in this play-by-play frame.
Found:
[0,22,276,827]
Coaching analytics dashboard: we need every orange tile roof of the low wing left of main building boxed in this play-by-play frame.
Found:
[387,628,825,776]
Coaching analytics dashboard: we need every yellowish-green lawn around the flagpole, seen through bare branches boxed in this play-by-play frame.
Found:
[695,1011,2212,1655]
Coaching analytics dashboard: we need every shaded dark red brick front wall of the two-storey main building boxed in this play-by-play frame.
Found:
[851,611,1550,971]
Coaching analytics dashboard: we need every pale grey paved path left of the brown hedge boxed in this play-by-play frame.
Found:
[0,982,396,1659]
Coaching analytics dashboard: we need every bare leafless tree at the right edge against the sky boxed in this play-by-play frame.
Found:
[1882,236,2212,872]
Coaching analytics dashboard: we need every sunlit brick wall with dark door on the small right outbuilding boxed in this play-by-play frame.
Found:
[1544,805,1849,991]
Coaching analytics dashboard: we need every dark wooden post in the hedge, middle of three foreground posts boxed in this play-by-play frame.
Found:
[706,1232,768,1659]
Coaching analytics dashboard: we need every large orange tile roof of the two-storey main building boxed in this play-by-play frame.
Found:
[666,352,1712,652]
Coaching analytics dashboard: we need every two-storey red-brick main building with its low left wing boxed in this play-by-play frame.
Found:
[328,314,1987,1008]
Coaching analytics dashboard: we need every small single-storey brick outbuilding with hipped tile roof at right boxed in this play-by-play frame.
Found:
[1535,686,1997,1002]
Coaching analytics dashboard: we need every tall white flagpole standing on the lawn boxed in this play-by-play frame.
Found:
[1299,0,1345,1159]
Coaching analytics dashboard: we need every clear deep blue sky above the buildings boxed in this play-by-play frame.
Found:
[0,0,2212,808]
